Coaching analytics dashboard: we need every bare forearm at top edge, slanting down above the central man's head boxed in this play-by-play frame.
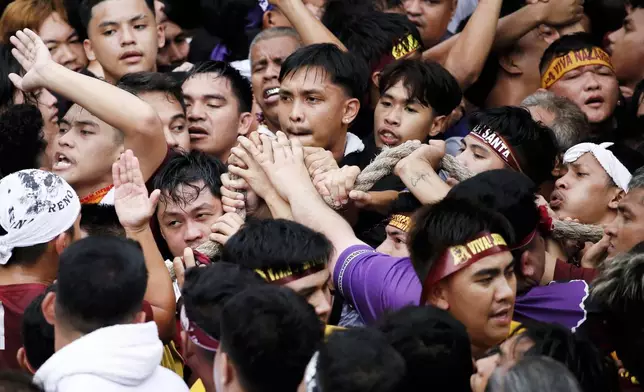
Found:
[280,0,347,52]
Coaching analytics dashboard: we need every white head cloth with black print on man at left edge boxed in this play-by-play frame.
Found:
[0,169,80,265]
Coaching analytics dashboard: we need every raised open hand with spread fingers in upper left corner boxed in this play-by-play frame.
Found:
[9,29,54,91]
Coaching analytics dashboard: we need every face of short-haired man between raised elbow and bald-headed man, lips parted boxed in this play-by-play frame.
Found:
[183,73,241,162]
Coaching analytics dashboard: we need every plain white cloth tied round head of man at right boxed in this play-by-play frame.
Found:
[563,143,632,192]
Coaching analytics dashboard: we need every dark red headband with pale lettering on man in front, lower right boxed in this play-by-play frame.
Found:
[421,232,509,303]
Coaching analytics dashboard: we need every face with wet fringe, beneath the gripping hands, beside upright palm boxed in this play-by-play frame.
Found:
[157,181,223,257]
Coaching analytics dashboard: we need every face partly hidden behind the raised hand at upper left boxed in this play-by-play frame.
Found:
[38,12,87,72]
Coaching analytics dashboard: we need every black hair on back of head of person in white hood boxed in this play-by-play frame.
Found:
[56,236,148,334]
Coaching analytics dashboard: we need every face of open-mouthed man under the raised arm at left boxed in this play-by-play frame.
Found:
[52,105,123,191]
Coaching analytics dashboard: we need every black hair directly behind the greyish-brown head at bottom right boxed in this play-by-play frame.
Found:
[512,322,619,391]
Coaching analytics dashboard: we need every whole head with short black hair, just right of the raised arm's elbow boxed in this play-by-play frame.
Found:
[183,61,253,162]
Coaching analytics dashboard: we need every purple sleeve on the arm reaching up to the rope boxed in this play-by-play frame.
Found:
[333,245,422,325]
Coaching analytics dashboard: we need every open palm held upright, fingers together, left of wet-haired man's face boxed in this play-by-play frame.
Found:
[112,150,161,231]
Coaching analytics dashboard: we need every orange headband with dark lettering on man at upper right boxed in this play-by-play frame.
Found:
[541,46,615,88]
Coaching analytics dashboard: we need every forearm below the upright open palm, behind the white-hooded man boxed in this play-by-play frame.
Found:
[126,225,176,340]
